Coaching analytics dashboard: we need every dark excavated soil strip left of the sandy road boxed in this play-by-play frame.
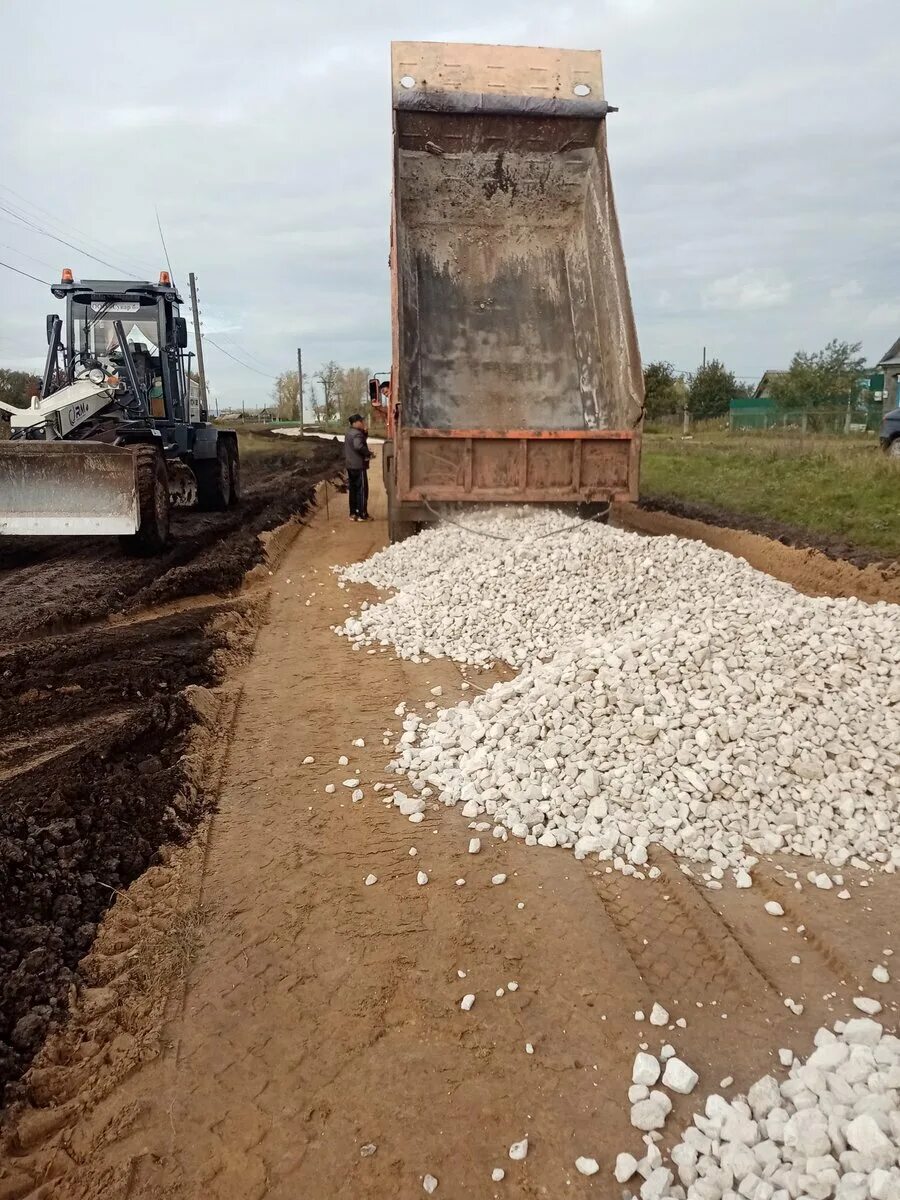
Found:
[0,443,337,1100]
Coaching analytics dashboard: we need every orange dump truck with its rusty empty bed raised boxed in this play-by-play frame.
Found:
[384,42,643,540]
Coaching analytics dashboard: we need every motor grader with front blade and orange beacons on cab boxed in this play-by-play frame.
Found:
[0,269,240,554]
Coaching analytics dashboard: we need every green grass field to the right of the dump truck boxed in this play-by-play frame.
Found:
[641,431,900,556]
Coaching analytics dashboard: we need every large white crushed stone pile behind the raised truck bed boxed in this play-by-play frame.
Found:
[338,512,900,887]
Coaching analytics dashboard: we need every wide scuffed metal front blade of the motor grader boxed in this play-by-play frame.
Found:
[0,440,139,536]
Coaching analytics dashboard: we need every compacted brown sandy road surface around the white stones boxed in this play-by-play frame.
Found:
[0,460,900,1200]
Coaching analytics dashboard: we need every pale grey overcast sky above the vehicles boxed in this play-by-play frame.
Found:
[0,0,900,407]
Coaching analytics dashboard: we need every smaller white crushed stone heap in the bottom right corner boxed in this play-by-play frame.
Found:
[614,1018,900,1200]
